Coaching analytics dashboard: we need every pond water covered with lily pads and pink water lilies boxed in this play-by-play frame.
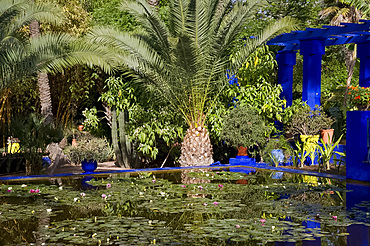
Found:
[0,170,370,246]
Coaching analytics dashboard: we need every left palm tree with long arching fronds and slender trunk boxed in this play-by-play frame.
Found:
[0,0,115,120]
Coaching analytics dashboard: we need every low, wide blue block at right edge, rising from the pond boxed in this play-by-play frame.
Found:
[346,111,370,182]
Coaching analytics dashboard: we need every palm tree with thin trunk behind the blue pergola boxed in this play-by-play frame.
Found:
[319,0,363,104]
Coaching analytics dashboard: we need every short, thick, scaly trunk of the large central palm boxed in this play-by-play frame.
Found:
[179,126,213,167]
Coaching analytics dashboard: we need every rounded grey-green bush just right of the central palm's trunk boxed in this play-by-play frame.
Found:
[221,106,270,151]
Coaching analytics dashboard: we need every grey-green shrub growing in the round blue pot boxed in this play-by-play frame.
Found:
[64,133,113,164]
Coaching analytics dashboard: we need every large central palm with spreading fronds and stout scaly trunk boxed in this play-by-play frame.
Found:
[89,0,292,166]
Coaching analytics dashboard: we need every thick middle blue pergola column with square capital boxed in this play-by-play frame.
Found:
[300,39,325,109]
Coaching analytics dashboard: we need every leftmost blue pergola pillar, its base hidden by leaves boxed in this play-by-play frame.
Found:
[276,50,297,107]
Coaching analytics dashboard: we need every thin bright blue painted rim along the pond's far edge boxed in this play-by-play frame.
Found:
[0,157,346,181]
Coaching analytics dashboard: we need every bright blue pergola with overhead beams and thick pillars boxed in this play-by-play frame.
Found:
[267,20,370,108]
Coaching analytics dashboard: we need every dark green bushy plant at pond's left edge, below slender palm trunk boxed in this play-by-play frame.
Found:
[10,114,63,175]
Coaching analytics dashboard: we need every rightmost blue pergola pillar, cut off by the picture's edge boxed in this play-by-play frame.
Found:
[357,43,370,87]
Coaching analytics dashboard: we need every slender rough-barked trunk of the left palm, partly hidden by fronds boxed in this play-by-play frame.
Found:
[30,21,53,124]
